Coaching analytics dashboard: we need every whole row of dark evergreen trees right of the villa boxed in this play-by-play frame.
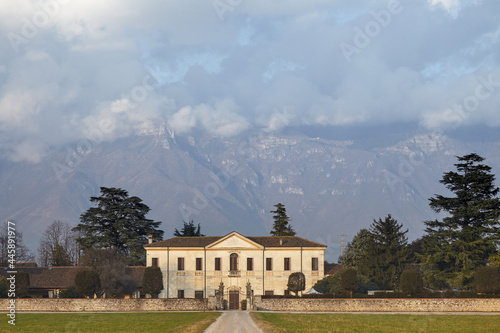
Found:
[316,153,500,293]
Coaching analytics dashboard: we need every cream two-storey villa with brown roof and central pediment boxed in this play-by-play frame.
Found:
[144,232,326,306]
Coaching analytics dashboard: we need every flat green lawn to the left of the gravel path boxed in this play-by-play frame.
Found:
[0,312,220,333]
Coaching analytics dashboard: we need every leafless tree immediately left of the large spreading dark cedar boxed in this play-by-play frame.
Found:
[38,221,80,266]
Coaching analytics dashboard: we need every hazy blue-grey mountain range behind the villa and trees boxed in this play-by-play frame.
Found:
[0,123,500,261]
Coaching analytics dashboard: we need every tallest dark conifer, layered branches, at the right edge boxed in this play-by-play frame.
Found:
[422,153,500,289]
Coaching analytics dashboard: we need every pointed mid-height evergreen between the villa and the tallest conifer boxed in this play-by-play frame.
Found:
[358,214,408,289]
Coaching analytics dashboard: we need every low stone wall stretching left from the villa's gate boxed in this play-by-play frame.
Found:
[0,298,209,312]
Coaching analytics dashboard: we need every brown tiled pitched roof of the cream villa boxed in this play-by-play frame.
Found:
[144,232,326,248]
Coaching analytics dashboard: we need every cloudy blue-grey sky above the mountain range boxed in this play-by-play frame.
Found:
[0,0,500,163]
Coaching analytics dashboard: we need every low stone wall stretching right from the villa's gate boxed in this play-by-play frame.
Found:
[254,296,500,312]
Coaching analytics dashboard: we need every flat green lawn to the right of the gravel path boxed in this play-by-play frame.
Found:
[252,312,500,333]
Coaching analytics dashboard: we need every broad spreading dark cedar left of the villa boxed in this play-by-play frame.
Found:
[75,187,163,265]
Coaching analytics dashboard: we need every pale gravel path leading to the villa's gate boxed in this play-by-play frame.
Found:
[204,311,263,333]
